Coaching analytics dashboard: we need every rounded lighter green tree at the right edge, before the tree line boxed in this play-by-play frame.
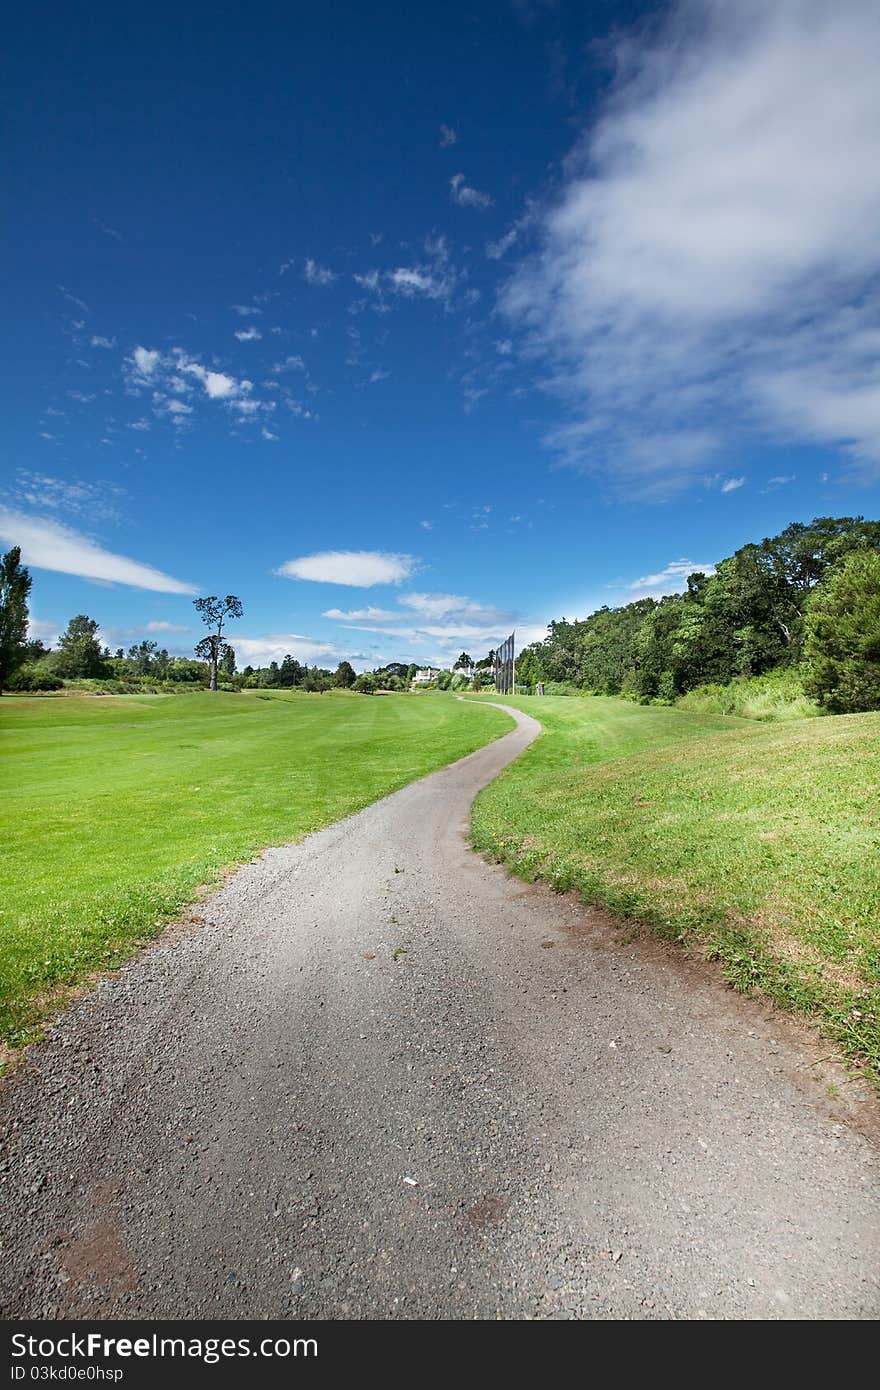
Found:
[805,550,880,714]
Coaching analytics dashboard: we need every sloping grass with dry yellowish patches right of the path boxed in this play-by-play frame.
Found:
[473,698,880,1081]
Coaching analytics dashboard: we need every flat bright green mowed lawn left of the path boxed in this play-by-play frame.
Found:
[0,692,512,1044]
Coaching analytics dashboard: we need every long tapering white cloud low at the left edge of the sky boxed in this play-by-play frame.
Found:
[0,507,199,594]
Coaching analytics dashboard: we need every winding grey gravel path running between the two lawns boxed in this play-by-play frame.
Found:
[0,700,880,1318]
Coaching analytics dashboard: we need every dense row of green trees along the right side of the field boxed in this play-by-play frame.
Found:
[517,517,880,713]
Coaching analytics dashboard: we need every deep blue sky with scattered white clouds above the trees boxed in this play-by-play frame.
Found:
[0,0,880,667]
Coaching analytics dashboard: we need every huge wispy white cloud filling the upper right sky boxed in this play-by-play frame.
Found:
[502,0,880,496]
